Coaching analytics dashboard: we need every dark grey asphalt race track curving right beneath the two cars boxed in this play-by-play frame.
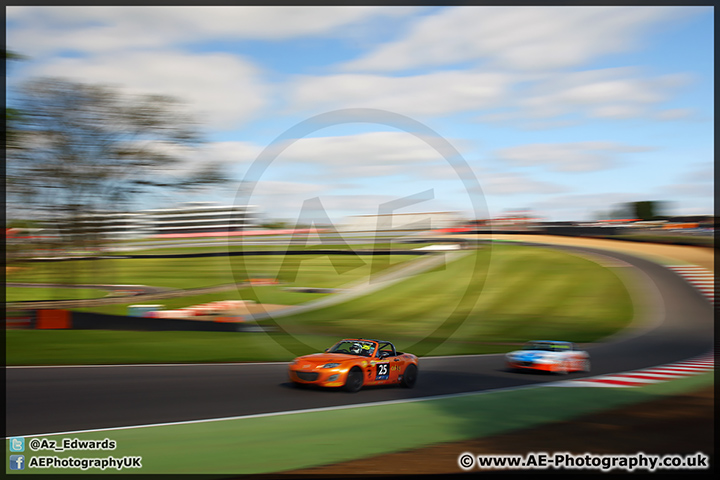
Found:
[5,247,714,436]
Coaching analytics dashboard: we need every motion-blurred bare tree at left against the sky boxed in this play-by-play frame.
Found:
[6,78,227,249]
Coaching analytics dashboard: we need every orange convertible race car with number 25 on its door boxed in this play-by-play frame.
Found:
[289,338,418,392]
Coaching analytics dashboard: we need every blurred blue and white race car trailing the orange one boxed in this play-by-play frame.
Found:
[505,340,590,374]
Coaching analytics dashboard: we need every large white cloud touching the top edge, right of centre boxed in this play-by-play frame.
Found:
[344,6,687,71]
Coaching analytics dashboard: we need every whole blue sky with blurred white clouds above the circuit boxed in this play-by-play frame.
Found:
[6,6,714,222]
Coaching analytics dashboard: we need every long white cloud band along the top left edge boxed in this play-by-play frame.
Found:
[6,6,414,56]
